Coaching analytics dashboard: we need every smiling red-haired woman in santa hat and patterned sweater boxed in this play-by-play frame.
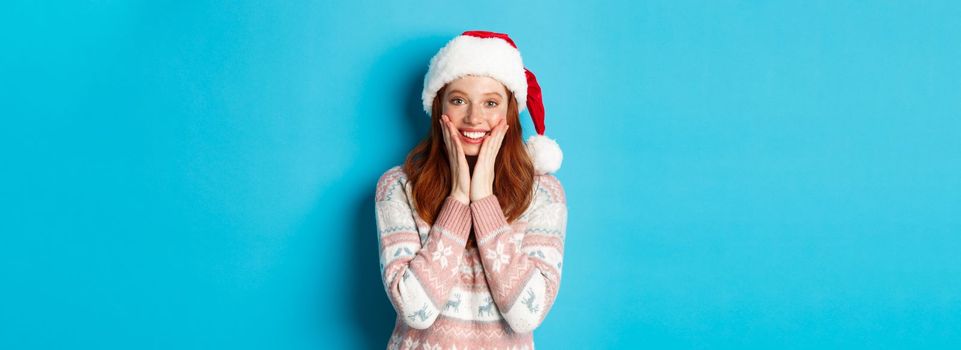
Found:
[375,31,567,349]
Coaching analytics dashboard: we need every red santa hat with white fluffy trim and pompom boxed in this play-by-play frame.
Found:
[421,30,564,174]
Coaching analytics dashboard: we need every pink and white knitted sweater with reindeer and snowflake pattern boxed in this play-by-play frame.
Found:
[375,166,567,350]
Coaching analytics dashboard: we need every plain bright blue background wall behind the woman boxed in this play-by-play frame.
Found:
[0,1,961,349]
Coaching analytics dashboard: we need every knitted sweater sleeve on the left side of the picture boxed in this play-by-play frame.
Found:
[375,167,471,329]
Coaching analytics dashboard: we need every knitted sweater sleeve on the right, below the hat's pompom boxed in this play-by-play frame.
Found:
[470,175,567,333]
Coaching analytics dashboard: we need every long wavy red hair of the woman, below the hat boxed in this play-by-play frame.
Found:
[404,85,535,225]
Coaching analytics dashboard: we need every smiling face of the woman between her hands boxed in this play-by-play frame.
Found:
[441,75,507,156]
